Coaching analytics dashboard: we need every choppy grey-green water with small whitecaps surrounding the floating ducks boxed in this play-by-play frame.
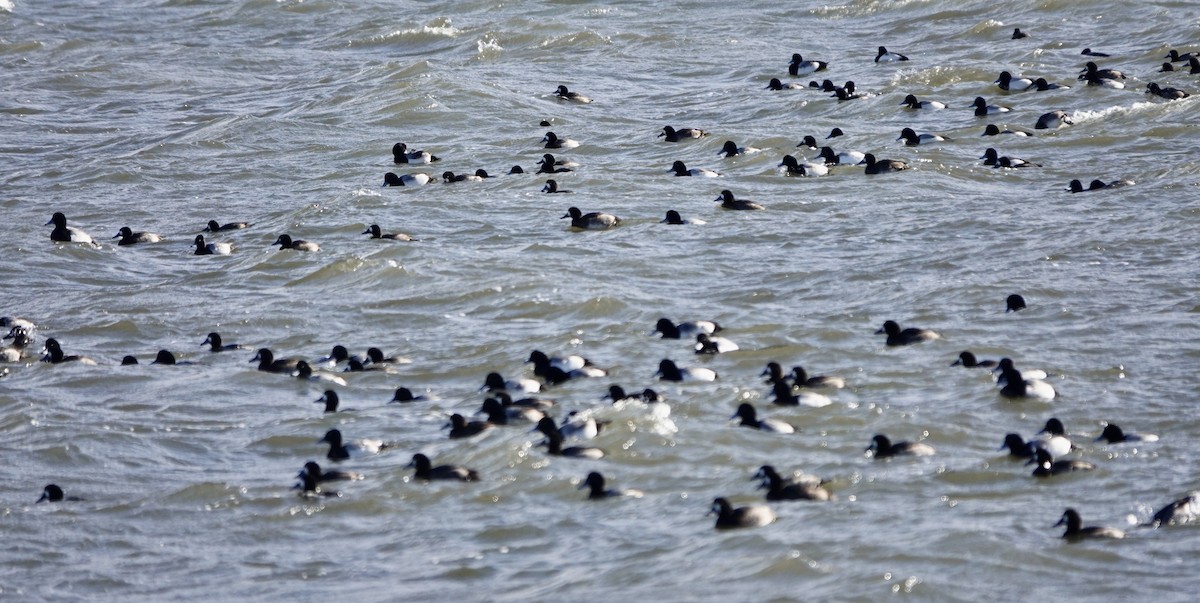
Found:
[0,0,1200,601]
